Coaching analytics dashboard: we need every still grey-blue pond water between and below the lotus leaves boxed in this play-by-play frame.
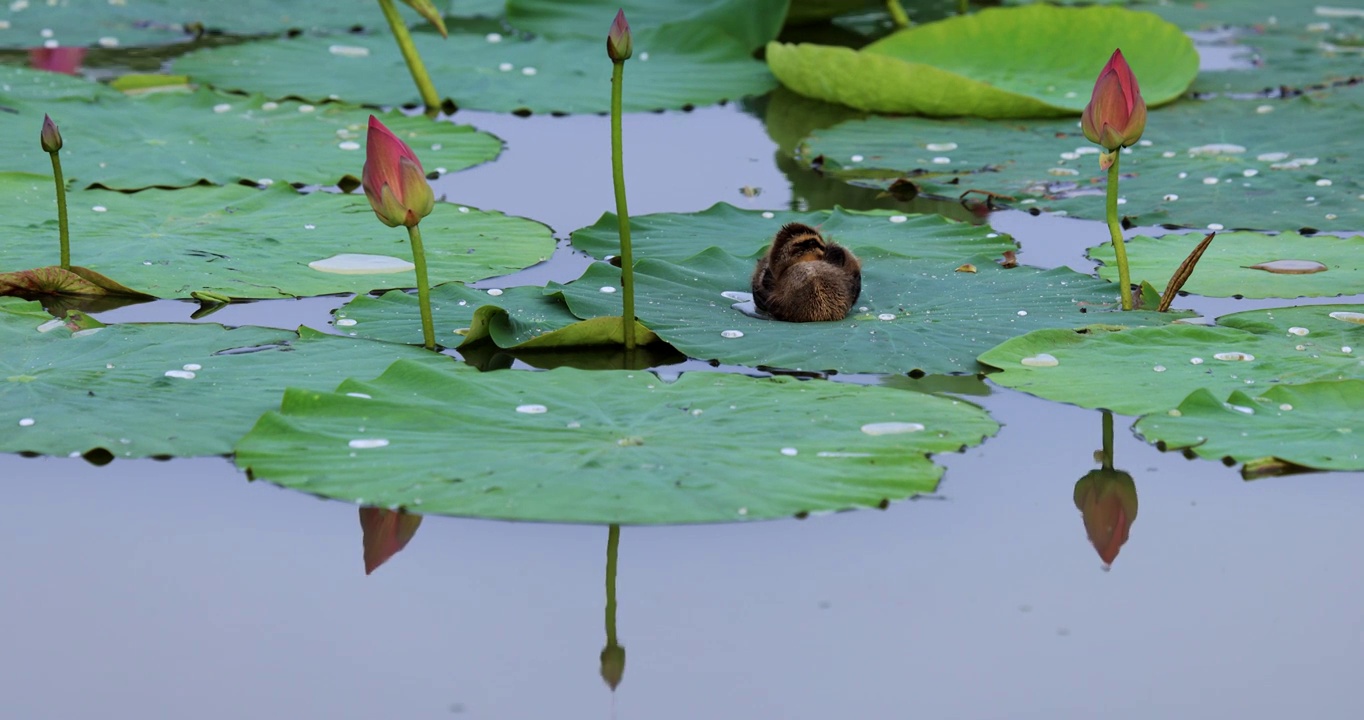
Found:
[0,81,1364,720]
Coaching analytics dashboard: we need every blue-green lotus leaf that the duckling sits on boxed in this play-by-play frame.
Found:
[551,245,1172,374]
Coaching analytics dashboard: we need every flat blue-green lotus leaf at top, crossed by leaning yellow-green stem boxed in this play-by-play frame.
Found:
[173,22,775,113]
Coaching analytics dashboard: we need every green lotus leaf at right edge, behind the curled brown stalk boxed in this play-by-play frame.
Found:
[1088,232,1364,297]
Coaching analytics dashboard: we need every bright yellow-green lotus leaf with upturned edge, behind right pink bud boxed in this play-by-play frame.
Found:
[767,5,1198,117]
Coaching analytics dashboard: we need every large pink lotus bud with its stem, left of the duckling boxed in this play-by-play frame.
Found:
[360,115,435,350]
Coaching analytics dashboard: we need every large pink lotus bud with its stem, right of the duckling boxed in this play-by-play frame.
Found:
[1080,49,1146,310]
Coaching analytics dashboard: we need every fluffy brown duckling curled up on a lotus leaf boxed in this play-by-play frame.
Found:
[752,222,862,322]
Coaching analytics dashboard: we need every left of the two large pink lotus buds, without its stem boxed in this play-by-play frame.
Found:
[360,115,435,228]
